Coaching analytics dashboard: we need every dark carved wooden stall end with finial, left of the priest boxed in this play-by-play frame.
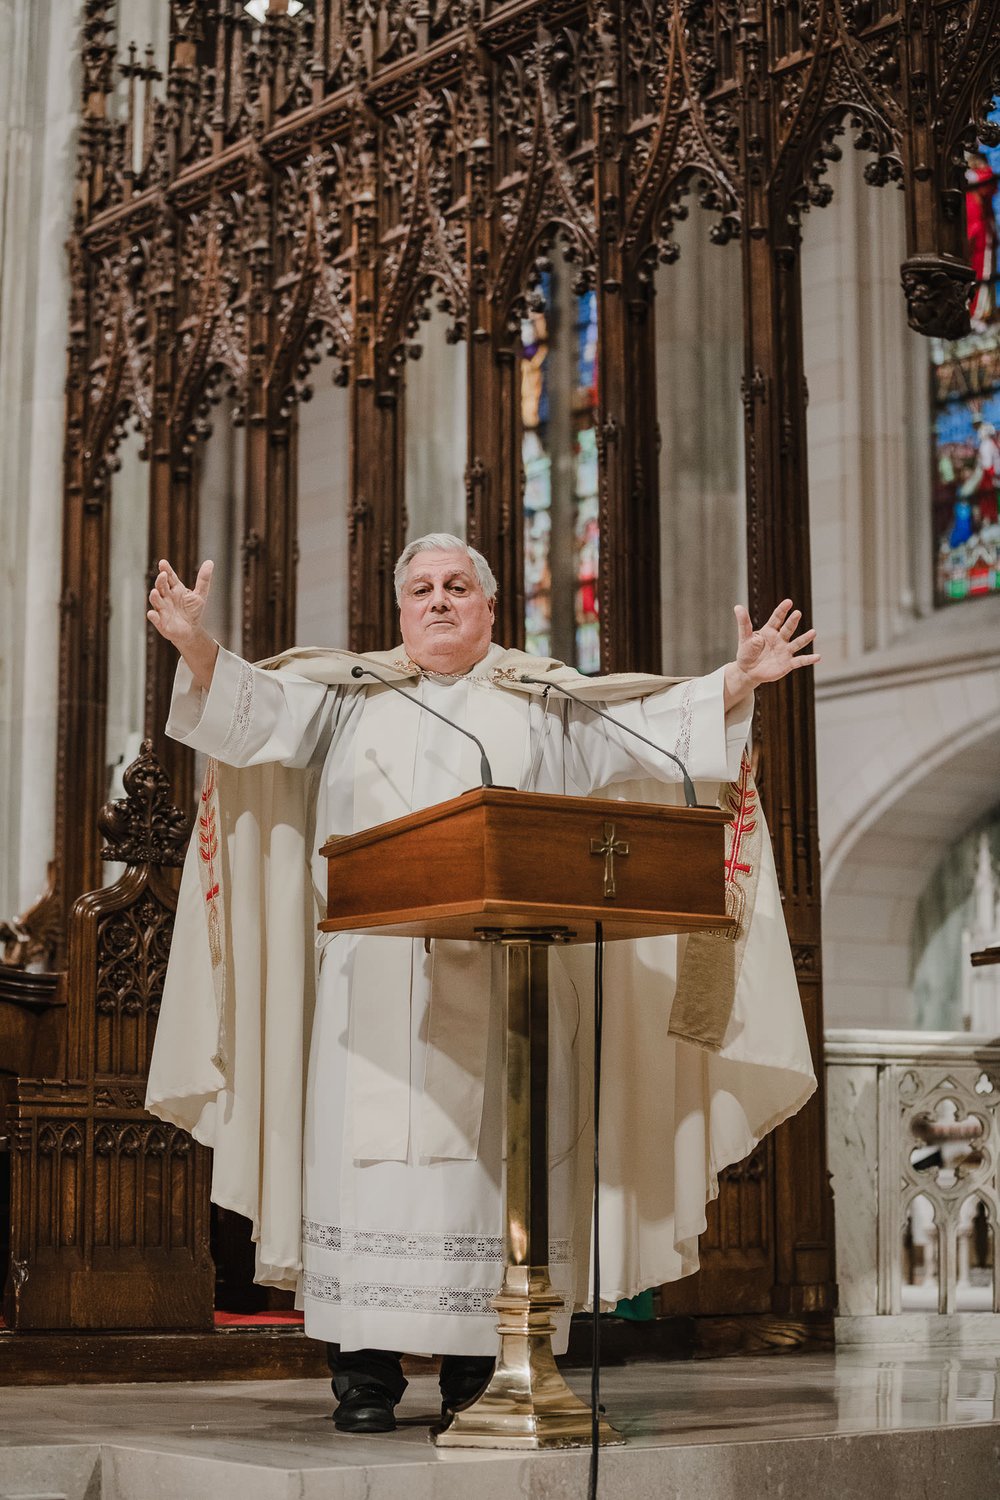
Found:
[0,741,214,1331]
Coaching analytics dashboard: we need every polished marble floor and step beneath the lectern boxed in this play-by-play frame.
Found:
[0,1346,1000,1500]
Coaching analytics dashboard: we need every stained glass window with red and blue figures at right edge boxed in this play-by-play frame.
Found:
[931,107,1000,605]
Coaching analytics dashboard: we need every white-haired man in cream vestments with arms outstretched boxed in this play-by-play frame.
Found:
[147,533,819,1431]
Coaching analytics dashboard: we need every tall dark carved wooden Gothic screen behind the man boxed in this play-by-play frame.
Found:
[50,0,1000,1338]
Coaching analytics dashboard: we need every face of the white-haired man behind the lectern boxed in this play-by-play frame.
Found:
[399,552,493,674]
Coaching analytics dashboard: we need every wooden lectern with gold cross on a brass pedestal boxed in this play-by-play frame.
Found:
[319,788,729,1449]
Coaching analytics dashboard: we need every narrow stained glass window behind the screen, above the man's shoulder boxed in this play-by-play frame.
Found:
[520,273,601,672]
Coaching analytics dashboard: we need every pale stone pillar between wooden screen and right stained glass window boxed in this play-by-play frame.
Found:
[802,152,933,669]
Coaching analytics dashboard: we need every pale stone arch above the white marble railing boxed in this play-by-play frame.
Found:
[817,627,1000,1026]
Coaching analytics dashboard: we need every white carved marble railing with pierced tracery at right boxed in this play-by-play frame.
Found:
[826,1031,1000,1341]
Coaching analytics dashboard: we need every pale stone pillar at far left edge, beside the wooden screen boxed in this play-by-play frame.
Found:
[0,0,81,915]
